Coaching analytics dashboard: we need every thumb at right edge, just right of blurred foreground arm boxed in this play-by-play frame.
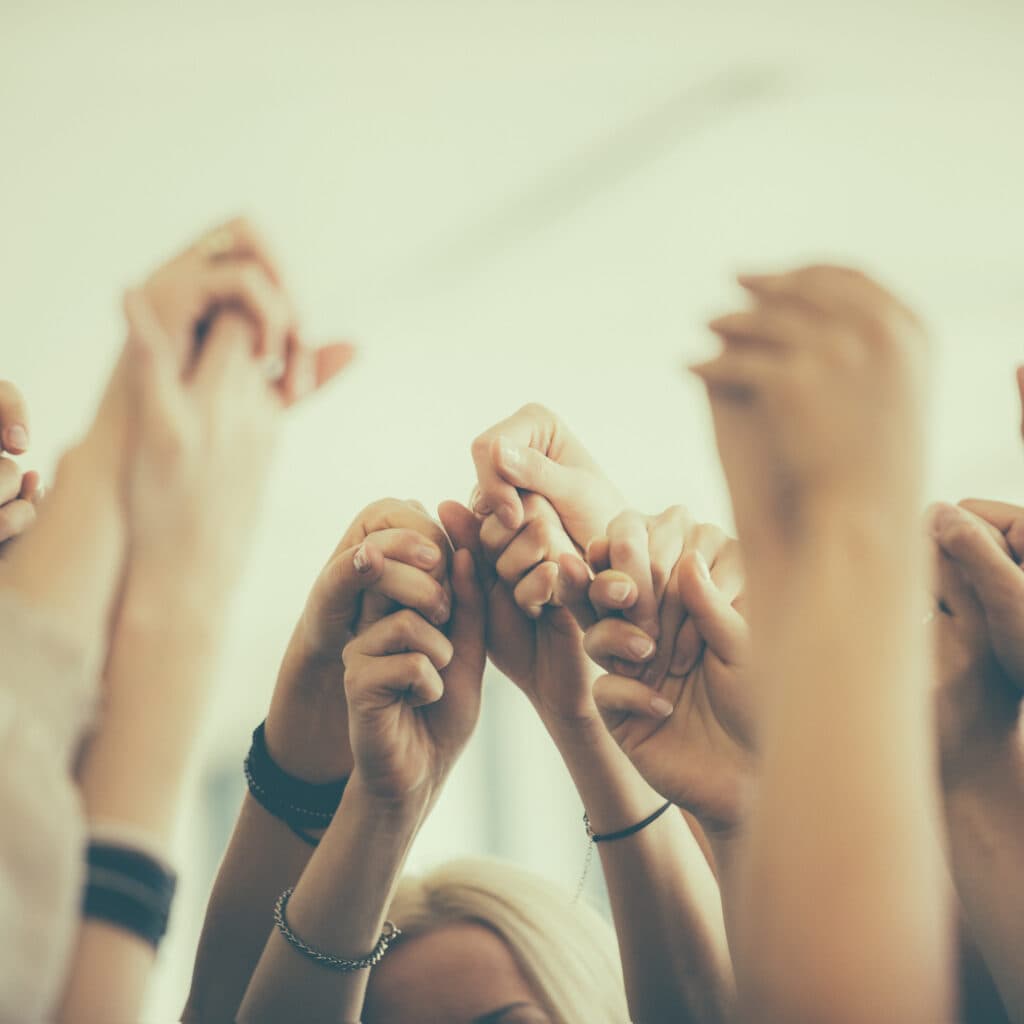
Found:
[932,505,1024,616]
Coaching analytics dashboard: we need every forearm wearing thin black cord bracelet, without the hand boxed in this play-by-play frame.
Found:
[550,721,734,1024]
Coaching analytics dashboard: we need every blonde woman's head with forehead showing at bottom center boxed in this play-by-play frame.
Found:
[364,859,629,1024]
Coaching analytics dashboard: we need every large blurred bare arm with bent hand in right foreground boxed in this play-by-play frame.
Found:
[695,267,953,1024]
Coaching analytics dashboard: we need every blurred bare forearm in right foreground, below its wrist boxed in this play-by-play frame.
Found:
[734,518,951,1022]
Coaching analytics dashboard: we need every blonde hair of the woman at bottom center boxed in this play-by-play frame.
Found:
[389,858,630,1024]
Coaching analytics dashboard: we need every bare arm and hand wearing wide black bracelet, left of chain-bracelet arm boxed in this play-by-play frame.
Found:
[184,501,447,1022]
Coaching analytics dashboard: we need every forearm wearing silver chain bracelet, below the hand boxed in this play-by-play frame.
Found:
[238,773,428,1024]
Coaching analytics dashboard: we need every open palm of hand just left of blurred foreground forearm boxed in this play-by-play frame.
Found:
[606,627,751,830]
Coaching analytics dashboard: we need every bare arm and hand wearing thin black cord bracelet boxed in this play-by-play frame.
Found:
[441,495,732,1024]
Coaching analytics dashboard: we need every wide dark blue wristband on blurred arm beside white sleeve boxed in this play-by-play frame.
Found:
[82,840,177,948]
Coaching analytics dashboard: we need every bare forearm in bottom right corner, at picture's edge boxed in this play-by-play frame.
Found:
[944,730,1024,1022]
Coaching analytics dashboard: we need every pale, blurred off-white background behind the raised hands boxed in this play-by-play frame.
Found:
[0,0,1024,1022]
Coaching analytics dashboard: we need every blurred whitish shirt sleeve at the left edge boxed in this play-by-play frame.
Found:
[0,590,98,1024]
